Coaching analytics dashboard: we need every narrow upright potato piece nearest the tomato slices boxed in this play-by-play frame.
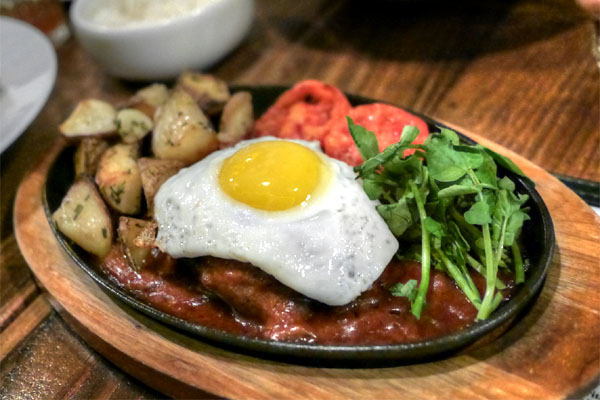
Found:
[217,92,254,148]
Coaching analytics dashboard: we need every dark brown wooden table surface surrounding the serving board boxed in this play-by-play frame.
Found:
[0,0,600,399]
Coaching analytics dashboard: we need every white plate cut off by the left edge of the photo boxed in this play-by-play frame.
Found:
[0,17,56,152]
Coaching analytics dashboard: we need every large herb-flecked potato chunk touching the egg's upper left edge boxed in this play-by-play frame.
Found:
[152,90,218,165]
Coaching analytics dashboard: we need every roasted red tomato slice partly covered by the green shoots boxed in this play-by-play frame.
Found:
[323,103,429,166]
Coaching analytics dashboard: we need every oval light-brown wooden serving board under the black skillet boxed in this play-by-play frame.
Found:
[14,129,600,399]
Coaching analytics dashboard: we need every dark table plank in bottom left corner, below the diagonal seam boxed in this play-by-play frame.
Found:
[0,312,164,399]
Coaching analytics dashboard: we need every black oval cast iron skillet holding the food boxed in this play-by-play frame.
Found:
[43,86,554,367]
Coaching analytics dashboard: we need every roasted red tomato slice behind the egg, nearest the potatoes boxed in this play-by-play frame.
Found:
[253,80,351,143]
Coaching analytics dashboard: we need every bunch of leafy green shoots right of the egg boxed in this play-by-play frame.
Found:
[347,117,529,319]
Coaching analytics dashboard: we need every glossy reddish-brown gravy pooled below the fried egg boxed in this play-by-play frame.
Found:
[100,245,512,345]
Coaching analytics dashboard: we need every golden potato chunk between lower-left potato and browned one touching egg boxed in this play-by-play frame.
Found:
[96,143,142,215]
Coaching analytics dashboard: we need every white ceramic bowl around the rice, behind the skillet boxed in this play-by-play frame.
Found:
[70,0,254,80]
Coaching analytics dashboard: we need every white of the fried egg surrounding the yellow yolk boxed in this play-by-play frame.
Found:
[154,137,398,305]
